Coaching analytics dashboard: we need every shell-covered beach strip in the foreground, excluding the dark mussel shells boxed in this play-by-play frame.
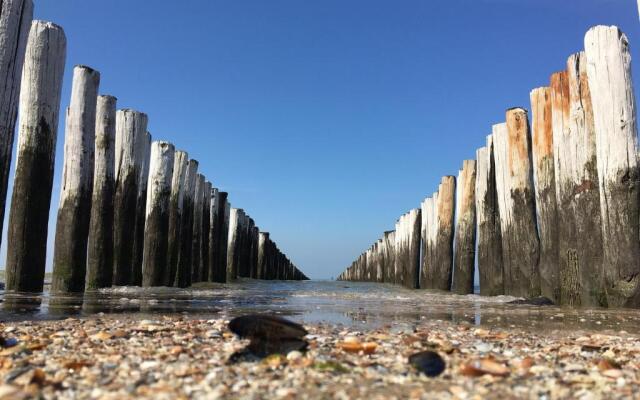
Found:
[0,315,640,399]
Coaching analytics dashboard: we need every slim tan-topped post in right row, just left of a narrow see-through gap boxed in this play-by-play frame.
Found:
[453,160,476,294]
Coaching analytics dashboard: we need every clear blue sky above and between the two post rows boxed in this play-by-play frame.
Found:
[0,0,640,278]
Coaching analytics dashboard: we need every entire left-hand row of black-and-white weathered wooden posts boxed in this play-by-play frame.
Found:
[0,0,307,292]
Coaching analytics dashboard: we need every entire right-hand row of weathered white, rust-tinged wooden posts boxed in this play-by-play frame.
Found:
[339,26,640,307]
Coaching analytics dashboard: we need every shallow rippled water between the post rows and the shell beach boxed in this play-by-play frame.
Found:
[0,280,640,332]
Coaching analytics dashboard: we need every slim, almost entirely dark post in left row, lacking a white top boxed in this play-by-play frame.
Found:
[209,190,230,283]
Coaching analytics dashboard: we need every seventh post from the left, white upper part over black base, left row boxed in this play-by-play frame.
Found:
[142,142,175,287]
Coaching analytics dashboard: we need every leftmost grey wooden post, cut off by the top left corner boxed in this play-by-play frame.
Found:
[0,0,33,250]
